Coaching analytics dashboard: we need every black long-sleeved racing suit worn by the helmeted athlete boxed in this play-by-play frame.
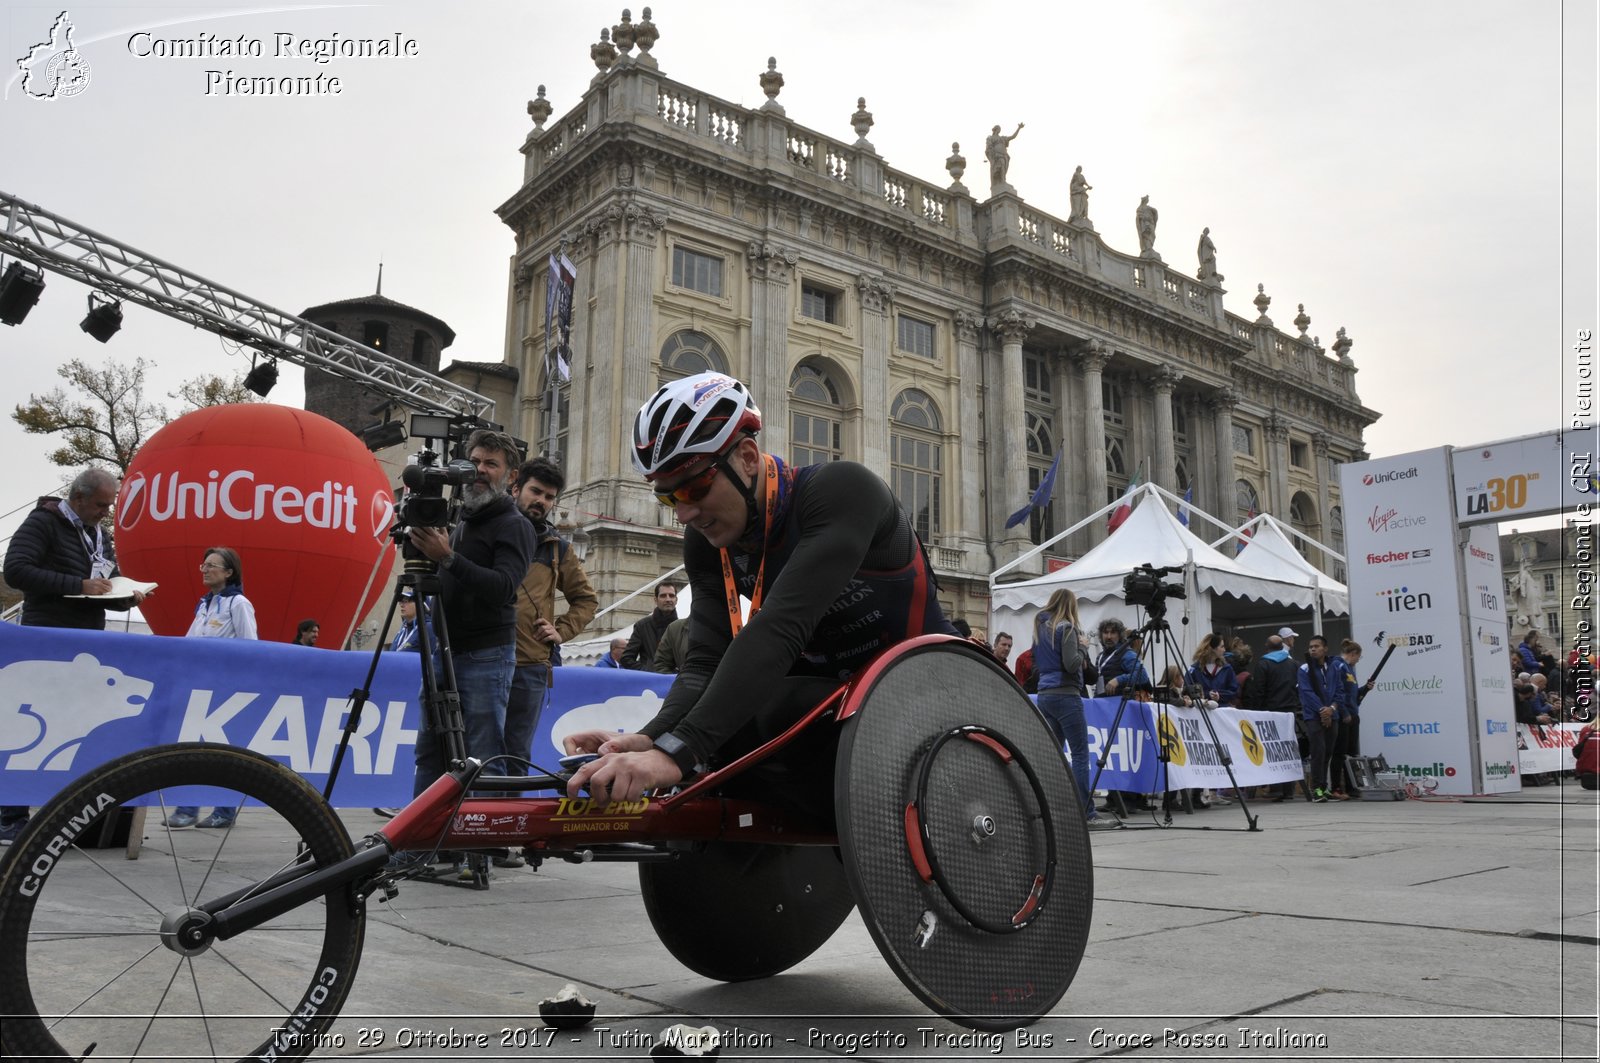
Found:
[642,461,955,815]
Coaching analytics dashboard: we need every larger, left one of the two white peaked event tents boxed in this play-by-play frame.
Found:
[989,483,1349,653]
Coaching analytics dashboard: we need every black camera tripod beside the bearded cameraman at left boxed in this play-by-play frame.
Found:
[322,547,493,890]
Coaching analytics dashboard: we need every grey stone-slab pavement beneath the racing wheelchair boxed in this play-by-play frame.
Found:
[6,781,1600,1060]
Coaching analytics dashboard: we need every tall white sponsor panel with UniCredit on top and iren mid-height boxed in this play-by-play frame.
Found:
[1337,447,1472,794]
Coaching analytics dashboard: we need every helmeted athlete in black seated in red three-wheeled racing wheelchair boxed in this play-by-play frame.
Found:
[0,375,1093,1060]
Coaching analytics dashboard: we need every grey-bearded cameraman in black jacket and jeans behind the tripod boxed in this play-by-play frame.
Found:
[408,429,534,806]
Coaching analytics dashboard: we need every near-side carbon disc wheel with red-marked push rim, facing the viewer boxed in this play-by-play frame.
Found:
[835,640,1094,1029]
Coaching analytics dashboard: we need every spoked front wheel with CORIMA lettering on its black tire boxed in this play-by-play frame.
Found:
[0,744,365,1063]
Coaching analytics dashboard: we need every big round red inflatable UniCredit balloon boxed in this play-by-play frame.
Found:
[117,403,395,647]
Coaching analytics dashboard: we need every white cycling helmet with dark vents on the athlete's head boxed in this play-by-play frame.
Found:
[634,373,762,480]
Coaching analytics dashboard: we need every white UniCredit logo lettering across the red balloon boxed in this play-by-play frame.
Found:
[117,469,355,532]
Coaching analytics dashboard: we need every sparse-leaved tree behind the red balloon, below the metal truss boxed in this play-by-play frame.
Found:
[11,359,254,475]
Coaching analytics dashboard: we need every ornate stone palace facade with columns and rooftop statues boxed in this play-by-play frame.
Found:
[499,11,1378,623]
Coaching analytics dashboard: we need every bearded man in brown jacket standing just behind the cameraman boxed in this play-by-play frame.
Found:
[506,458,600,794]
